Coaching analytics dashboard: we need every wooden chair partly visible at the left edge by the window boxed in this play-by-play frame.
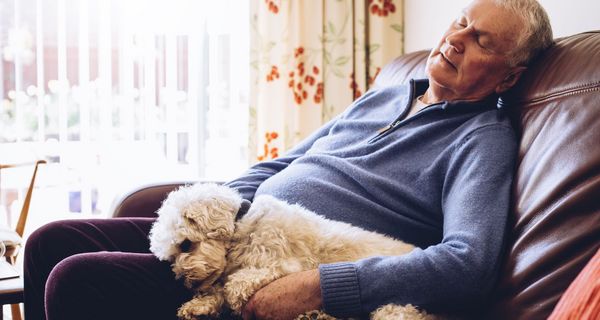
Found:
[0,160,46,320]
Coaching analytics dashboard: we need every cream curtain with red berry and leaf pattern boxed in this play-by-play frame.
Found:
[250,0,404,161]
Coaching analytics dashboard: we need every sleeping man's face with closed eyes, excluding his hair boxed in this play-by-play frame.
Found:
[426,0,523,100]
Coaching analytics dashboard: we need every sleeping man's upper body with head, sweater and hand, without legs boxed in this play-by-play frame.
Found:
[234,0,552,319]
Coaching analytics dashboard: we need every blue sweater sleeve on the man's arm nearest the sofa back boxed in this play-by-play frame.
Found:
[319,125,517,317]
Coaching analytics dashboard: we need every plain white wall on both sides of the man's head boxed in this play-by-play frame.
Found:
[404,0,600,52]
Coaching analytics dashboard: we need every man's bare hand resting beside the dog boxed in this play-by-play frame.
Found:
[242,269,323,320]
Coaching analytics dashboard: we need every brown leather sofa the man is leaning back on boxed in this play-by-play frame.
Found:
[114,31,600,320]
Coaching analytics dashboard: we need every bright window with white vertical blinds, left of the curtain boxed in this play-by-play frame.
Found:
[0,0,249,230]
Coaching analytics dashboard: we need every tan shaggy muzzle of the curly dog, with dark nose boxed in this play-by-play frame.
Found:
[172,239,228,290]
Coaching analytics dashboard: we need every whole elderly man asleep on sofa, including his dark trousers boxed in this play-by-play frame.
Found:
[25,0,552,320]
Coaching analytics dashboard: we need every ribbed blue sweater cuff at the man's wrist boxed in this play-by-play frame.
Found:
[319,262,361,318]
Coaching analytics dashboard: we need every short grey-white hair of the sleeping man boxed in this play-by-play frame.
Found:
[494,0,554,66]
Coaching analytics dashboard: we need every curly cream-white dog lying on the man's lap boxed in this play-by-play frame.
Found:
[150,184,436,320]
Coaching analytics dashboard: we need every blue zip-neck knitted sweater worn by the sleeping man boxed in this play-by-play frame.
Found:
[227,80,517,317]
